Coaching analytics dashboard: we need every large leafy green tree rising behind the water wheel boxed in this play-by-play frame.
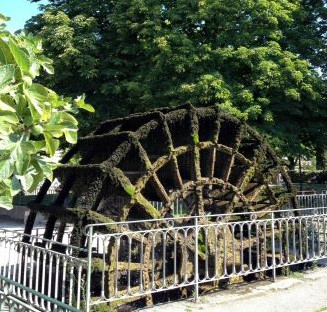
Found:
[27,0,324,157]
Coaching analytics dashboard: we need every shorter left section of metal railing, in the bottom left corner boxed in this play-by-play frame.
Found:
[0,230,86,311]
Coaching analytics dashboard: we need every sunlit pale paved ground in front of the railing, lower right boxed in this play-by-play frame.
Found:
[142,267,327,312]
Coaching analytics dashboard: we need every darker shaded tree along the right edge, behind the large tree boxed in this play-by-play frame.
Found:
[282,0,327,169]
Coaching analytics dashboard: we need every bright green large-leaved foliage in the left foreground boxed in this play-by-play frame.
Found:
[0,15,93,209]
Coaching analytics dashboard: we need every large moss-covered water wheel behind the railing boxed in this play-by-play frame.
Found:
[25,106,296,304]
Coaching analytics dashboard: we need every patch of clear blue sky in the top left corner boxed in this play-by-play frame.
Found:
[0,0,46,32]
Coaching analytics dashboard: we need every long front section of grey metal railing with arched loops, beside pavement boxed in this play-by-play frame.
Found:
[86,207,327,311]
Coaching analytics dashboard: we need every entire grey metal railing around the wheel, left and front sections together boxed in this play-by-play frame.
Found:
[0,194,327,312]
